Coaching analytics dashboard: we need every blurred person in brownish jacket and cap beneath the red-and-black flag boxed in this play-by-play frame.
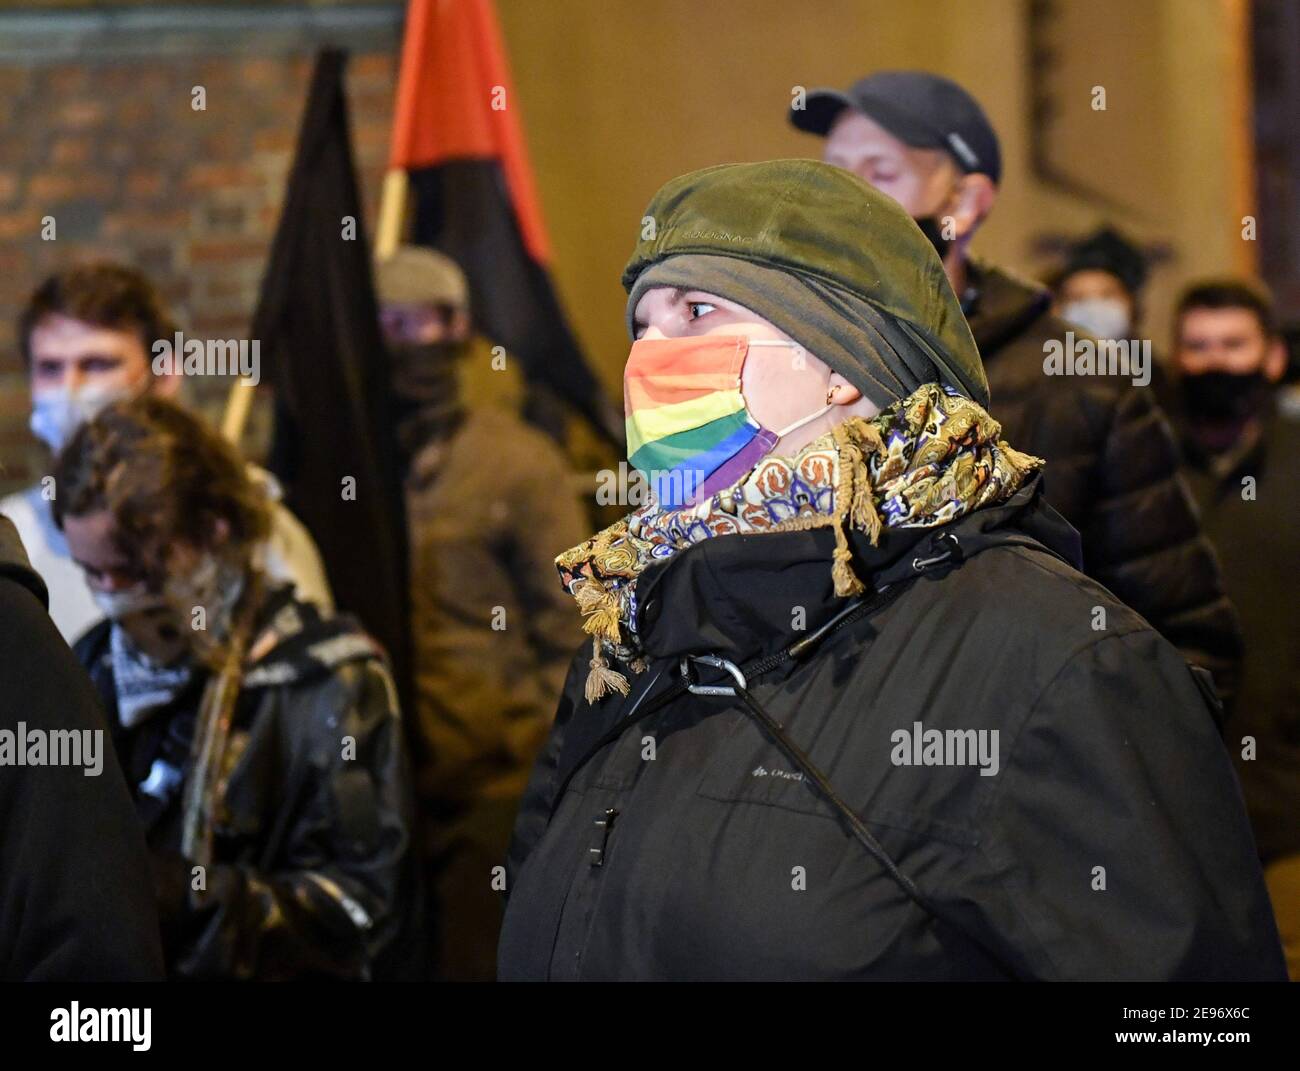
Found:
[376,246,586,981]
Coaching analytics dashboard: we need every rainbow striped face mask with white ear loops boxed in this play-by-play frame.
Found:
[623,335,831,510]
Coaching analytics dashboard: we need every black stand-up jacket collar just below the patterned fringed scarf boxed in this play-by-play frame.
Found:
[636,473,1080,663]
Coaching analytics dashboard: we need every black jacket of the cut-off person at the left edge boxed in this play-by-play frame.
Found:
[0,517,163,981]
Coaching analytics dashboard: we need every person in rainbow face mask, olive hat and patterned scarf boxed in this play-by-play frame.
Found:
[498,160,1284,980]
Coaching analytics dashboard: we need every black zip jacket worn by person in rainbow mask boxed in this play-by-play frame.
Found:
[498,477,1284,980]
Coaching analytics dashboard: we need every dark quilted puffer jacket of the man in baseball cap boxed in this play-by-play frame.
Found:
[967,263,1243,702]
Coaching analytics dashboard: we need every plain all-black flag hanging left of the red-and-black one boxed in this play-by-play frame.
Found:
[252,51,410,695]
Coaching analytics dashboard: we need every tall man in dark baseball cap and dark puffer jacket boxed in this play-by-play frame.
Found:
[789,70,1242,695]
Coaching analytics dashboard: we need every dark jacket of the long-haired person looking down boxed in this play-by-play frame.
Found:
[75,587,417,980]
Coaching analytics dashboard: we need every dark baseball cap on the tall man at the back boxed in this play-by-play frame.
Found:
[790,70,1002,183]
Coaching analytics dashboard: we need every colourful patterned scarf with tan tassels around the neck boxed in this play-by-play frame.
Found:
[555,383,1043,703]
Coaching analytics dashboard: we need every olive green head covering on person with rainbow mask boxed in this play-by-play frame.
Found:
[623,160,988,407]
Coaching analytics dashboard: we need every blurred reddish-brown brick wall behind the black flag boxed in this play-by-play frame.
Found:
[0,10,397,491]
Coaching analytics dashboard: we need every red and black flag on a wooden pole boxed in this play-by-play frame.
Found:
[389,0,623,442]
